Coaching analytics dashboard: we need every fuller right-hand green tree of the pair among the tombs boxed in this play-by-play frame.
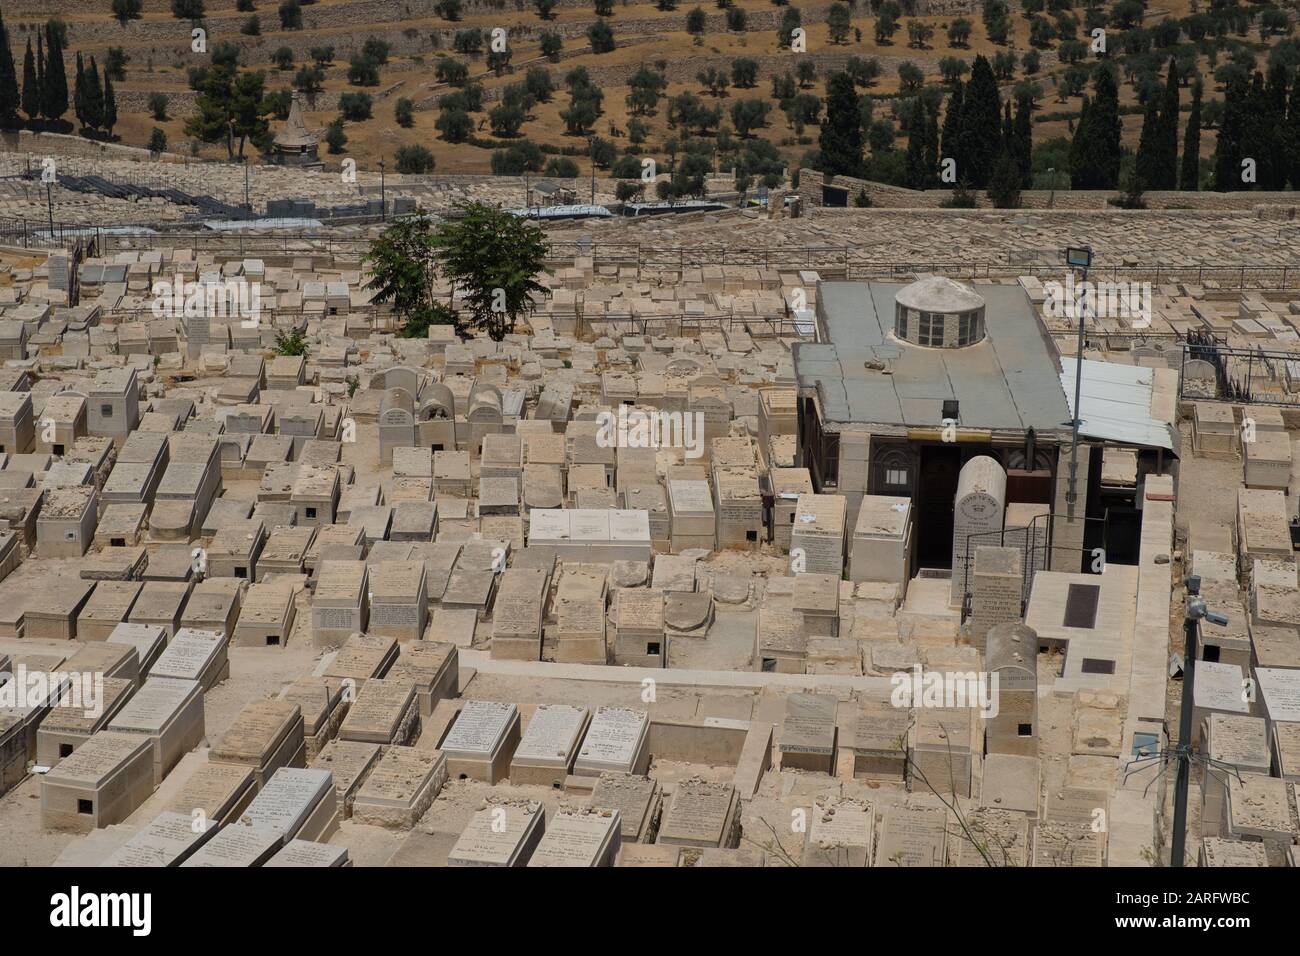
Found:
[433,203,547,342]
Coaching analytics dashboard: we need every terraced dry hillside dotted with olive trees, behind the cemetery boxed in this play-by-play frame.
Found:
[5,0,1300,186]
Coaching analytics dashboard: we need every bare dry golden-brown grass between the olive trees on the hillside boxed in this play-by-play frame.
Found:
[7,0,1279,173]
